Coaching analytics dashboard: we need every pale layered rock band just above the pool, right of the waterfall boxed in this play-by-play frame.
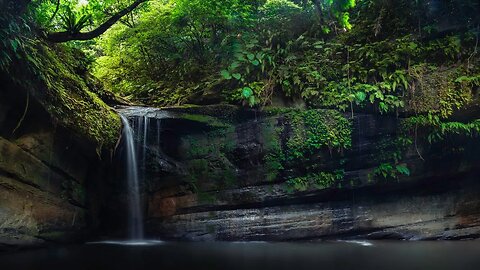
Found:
[149,176,480,241]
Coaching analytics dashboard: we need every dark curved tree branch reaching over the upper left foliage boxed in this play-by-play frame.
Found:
[47,0,148,43]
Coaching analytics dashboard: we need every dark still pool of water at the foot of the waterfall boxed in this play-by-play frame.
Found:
[0,241,480,270]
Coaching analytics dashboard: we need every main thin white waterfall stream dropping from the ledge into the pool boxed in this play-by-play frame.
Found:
[120,115,143,240]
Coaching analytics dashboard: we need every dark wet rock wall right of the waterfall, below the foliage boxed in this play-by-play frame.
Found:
[130,107,480,240]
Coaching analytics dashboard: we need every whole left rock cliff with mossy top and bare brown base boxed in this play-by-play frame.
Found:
[0,38,120,249]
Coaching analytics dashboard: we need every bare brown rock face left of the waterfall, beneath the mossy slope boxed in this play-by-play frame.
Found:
[0,85,105,250]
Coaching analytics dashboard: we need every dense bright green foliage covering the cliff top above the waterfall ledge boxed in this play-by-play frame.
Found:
[54,0,479,113]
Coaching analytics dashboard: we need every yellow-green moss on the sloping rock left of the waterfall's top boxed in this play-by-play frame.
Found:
[20,41,121,151]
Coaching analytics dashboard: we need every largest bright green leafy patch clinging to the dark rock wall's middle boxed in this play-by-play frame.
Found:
[262,108,352,182]
